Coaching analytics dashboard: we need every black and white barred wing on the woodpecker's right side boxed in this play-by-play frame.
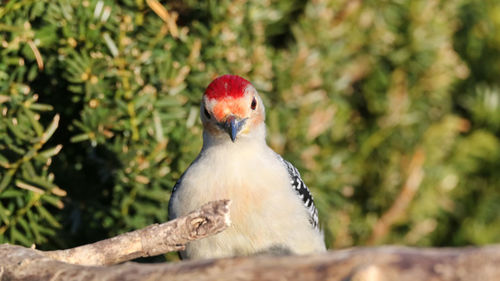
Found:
[276,154,319,229]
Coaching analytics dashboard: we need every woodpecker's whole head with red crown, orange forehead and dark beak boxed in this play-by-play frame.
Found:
[200,75,265,142]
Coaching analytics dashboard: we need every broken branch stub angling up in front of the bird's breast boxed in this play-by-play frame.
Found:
[44,200,231,265]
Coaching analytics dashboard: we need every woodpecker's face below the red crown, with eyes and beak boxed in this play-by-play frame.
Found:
[200,85,265,141]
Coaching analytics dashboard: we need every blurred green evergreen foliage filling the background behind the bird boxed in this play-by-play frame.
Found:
[0,0,500,256]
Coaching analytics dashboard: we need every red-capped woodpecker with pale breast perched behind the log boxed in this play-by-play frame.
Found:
[168,74,326,259]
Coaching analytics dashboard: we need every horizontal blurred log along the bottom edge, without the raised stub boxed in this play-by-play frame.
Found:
[0,244,500,281]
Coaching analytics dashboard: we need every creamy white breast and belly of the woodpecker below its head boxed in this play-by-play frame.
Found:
[172,140,325,258]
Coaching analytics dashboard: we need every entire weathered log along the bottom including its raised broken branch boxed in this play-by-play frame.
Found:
[0,200,500,281]
